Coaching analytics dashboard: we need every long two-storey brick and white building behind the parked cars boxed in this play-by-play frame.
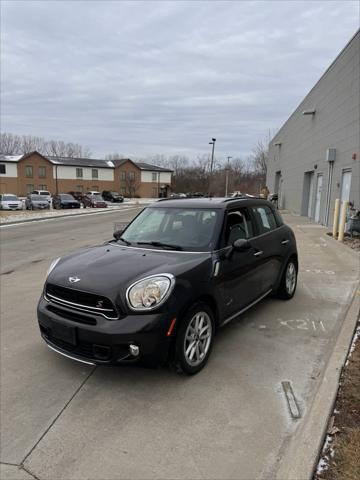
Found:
[0,152,172,198]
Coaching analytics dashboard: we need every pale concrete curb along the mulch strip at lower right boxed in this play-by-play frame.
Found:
[275,286,360,480]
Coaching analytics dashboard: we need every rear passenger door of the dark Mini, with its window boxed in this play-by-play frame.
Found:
[250,204,289,294]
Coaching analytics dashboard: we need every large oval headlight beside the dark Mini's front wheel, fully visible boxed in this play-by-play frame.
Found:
[126,273,175,310]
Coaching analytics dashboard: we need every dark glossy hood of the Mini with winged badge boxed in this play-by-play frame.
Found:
[47,243,212,300]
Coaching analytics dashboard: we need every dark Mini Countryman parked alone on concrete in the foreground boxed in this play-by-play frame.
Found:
[38,196,298,374]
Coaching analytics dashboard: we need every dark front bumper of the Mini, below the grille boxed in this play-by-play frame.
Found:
[37,296,172,365]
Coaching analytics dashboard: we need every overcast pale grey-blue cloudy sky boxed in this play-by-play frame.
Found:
[1,0,359,160]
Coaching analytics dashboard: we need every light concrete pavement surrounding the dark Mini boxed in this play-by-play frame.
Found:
[0,212,359,480]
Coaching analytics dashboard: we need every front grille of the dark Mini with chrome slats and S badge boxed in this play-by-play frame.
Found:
[45,283,119,320]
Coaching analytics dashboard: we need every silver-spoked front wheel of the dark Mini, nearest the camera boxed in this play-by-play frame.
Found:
[175,303,215,375]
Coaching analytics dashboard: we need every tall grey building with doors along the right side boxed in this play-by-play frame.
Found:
[267,30,360,225]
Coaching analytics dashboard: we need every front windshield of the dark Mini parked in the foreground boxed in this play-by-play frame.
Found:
[118,207,219,251]
